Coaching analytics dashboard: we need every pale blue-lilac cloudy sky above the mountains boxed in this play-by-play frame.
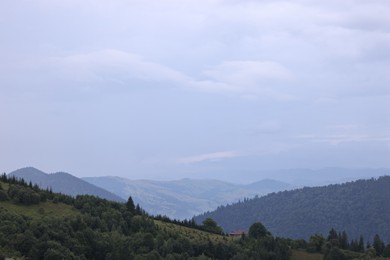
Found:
[0,0,390,181]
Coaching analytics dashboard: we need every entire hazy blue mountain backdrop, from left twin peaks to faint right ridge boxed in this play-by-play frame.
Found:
[6,167,389,219]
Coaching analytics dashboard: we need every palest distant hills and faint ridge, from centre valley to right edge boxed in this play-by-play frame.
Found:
[83,167,389,219]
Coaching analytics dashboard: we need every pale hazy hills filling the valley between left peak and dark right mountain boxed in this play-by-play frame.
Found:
[83,176,291,219]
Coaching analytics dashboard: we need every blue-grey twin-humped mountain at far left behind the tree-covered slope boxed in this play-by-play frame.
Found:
[9,167,125,202]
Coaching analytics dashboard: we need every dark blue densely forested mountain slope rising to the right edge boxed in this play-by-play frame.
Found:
[195,176,390,241]
